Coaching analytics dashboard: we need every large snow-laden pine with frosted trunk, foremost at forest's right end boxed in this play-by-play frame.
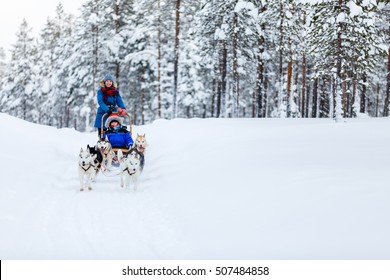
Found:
[310,0,380,120]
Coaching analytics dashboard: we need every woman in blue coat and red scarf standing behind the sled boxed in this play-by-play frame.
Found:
[94,74,127,139]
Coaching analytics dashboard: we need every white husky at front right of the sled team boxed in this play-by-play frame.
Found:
[118,149,141,191]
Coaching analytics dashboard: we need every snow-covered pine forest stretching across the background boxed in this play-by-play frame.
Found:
[0,0,390,131]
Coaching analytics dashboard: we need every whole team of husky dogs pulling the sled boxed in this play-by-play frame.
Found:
[79,134,147,191]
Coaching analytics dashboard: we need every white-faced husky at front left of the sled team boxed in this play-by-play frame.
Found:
[79,148,97,191]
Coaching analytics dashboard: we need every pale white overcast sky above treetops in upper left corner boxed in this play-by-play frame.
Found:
[0,0,83,59]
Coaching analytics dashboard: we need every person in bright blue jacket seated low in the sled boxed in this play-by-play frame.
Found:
[104,114,134,149]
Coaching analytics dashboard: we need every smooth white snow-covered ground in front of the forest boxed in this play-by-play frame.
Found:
[0,114,390,260]
